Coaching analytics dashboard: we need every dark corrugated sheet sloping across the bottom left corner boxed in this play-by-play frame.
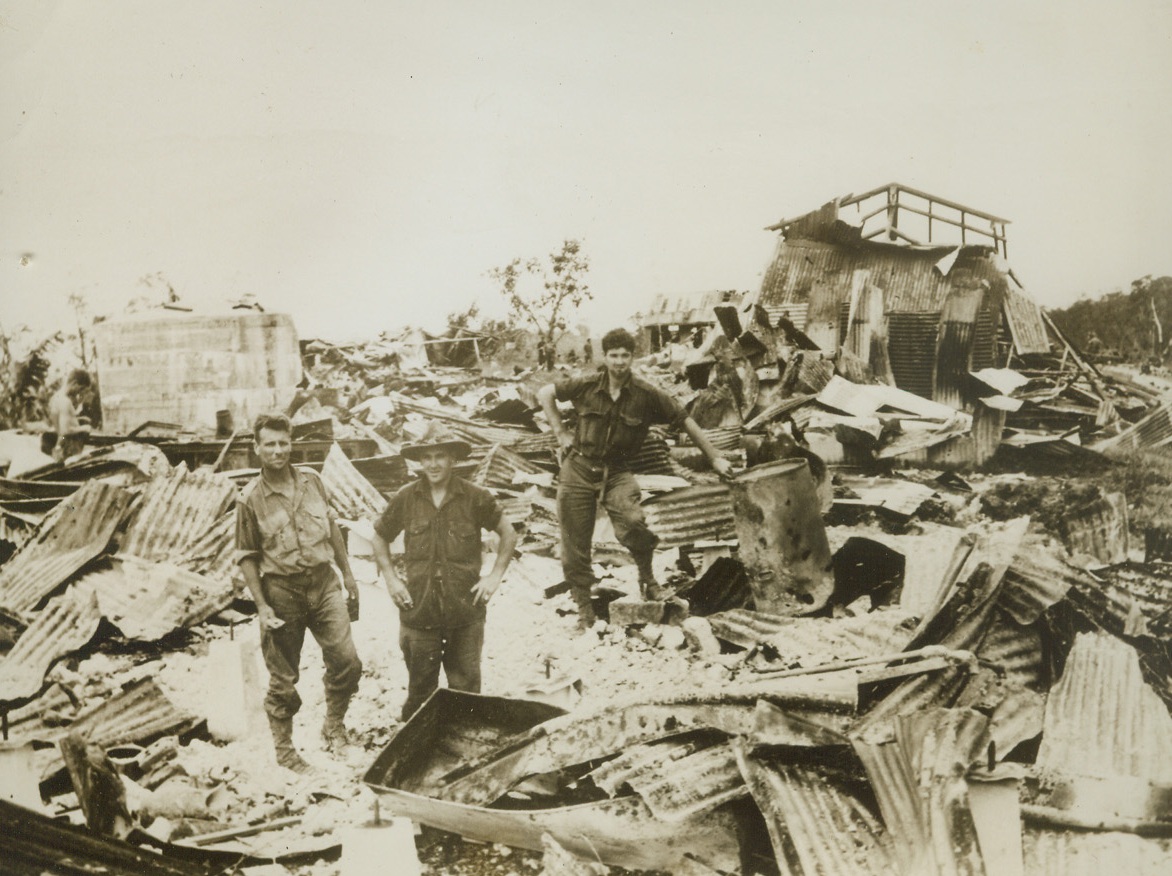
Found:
[0,797,207,876]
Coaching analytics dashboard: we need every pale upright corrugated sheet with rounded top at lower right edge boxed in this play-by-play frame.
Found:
[1037,633,1172,783]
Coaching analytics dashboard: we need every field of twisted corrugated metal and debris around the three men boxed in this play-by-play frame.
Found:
[0,308,1172,876]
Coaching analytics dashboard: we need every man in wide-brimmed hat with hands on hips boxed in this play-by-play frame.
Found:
[365,421,517,720]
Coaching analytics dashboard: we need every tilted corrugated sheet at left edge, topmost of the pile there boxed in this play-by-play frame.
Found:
[0,481,134,614]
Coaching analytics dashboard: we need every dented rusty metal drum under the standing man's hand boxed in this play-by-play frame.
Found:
[731,459,834,614]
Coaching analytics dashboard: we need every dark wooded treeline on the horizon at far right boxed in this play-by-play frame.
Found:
[1048,277,1172,366]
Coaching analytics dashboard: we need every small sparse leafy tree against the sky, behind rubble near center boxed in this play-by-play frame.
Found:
[489,239,594,365]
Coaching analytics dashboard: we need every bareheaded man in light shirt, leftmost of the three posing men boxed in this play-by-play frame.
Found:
[236,414,362,773]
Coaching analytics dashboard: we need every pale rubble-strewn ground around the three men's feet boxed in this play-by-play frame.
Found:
[70,544,712,876]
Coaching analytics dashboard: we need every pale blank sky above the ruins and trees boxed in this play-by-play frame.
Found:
[0,0,1172,340]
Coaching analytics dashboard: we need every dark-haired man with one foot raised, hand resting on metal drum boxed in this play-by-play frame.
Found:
[537,328,731,627]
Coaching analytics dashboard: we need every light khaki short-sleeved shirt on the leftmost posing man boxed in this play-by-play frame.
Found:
[236,467,334,575]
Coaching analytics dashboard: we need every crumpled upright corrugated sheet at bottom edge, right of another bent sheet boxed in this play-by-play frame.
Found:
[854,708,988,876]
